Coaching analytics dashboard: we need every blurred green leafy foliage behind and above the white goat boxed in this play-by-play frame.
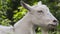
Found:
[0,0,60,33]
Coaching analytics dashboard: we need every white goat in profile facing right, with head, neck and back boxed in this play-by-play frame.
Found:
[0,1,58,34]
